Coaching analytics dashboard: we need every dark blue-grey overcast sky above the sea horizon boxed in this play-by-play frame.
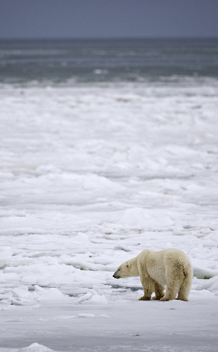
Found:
[0,0,218,38]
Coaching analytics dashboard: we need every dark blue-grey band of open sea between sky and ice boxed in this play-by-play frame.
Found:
[0,38,218,84]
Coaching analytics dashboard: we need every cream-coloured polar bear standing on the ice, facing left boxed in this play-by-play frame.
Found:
[113,248,193,301]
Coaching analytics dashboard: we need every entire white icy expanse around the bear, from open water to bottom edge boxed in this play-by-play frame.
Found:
[0,79,218,352]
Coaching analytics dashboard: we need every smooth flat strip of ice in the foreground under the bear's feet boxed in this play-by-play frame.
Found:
[0,294,218,352]
